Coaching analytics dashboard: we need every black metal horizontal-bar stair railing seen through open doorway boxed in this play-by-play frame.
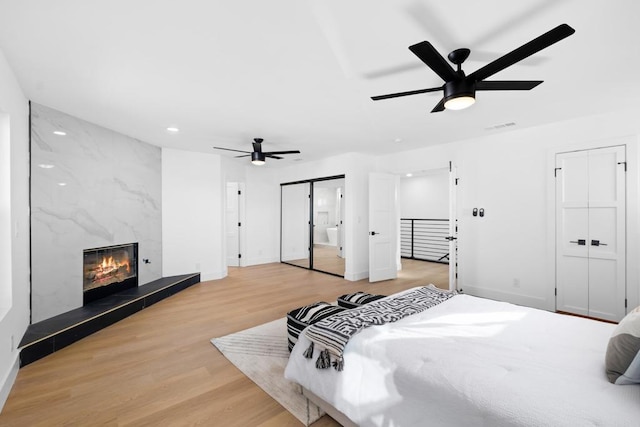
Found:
[400,218,449,264]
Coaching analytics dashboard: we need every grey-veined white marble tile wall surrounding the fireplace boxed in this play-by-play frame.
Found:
[31,103,162,322]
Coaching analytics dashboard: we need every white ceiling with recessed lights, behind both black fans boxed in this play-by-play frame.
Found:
[0,0,640,166]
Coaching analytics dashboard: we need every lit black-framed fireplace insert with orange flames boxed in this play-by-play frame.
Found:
[82,243,138,304]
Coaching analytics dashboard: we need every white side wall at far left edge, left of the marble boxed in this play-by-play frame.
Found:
[0,51,29,408]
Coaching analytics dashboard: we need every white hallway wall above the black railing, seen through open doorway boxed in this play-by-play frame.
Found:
[398,173,449,219]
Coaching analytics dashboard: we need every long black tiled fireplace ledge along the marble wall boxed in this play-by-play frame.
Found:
[19,273,200,367]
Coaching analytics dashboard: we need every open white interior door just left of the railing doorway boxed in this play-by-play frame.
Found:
[369,173,400,282]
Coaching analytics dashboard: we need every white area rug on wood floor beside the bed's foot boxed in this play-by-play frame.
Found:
[211,318,324,426]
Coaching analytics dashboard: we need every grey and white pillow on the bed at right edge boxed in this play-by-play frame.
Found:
[605,307,640,385]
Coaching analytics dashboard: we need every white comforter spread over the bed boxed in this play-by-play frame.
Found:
[285,295,640,427]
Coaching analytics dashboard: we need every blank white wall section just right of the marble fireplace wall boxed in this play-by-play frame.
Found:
[162,148,227,281]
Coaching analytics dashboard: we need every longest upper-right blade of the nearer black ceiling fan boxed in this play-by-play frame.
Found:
[467,24,576,82]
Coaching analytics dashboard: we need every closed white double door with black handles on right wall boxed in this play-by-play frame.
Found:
[556,147,626,321]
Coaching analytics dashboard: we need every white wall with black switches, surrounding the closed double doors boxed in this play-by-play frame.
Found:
[379,111,640,310]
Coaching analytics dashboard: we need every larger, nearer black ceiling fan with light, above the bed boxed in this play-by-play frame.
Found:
[371,24,575,113]
